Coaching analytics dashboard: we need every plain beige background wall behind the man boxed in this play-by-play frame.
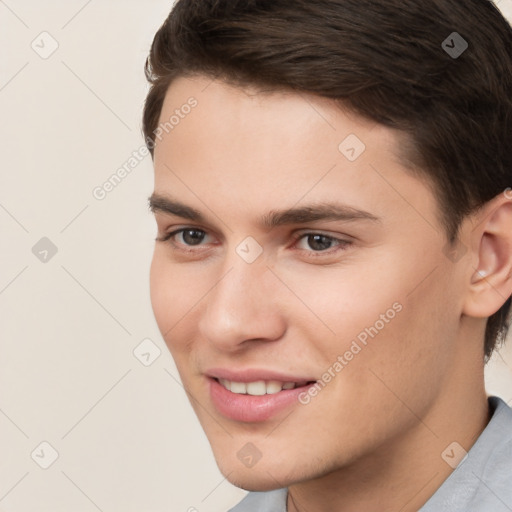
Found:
[0,0,512,512]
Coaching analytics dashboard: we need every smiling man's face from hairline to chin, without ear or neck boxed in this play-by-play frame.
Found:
[151,77,463,490]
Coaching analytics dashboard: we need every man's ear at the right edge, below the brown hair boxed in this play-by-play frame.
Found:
[462,189,512,318]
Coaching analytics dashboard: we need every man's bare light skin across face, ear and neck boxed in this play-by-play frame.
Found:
[147,76,512,512]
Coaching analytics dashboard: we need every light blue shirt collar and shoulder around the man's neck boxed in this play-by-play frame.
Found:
[229,396,512,512]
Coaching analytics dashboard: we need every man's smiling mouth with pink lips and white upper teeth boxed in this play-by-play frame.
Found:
[207,376,317,423]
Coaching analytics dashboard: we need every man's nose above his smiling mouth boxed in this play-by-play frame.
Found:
[199,254,286,352]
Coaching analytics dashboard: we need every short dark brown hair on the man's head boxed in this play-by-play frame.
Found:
[143,0,512,359]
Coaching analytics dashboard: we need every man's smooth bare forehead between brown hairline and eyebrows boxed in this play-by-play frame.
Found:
[155,77,435,235]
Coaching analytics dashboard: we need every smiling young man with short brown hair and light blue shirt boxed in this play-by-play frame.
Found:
[144,0,512,512]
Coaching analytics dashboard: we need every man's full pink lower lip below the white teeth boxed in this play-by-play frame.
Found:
[208,378,314,423]
